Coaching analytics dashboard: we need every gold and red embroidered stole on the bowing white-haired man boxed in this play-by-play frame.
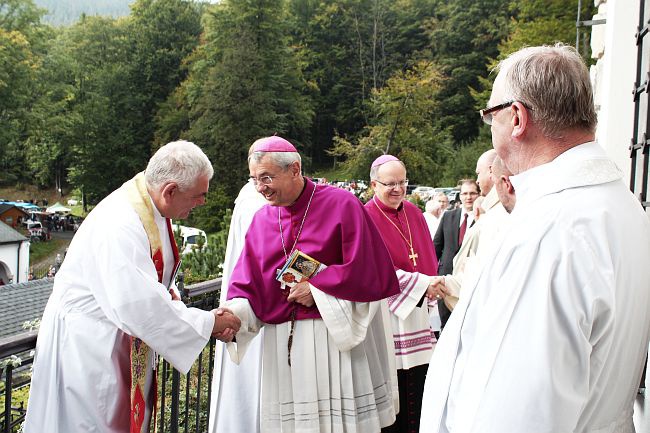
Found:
[122,172,178,433]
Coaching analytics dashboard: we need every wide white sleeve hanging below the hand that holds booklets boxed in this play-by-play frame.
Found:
[309,284,381,352]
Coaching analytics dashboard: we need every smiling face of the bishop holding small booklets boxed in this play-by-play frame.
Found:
[248,156,304,206]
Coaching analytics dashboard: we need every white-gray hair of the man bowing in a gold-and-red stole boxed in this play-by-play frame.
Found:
[144,140,214,190]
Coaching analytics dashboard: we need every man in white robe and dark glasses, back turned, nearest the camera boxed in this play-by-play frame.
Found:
[421,44,650,433]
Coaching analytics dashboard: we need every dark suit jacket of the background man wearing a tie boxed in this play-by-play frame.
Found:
[433,208,462,327]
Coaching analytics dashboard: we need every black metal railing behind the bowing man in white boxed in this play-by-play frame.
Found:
[0,275,221,433]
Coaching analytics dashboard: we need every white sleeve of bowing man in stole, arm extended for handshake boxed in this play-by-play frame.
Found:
[88,214,214,373]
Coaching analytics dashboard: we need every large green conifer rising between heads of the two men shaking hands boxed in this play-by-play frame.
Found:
[157,0,313,216]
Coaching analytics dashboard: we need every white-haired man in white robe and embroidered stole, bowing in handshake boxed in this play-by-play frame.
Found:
[24,141,240,433]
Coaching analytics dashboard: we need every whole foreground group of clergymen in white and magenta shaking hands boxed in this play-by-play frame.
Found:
[24,45,650,433]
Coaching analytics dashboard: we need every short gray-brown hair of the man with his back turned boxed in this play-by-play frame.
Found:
[496,43,597,139]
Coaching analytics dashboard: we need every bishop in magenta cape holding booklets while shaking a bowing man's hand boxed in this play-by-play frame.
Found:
[220,137,398,432]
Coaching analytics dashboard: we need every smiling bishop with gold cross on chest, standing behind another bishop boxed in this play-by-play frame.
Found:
[366,155,442,433]
